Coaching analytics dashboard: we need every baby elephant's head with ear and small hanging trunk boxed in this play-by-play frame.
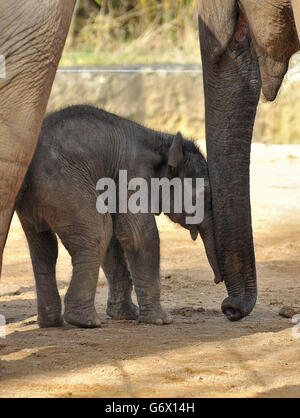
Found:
[161,133,222,283]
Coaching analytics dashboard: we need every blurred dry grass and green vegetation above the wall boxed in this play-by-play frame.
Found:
[61,0,200,66]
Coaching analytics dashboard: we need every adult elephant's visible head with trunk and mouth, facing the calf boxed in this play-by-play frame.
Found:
[199,0,300,320]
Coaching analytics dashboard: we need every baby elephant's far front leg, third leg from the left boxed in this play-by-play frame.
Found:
[102,235,139,319]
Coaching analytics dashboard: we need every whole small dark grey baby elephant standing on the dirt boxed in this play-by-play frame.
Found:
[16,106,220,328]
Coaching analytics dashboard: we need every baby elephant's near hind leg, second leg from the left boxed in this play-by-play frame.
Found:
[57,209,112,328]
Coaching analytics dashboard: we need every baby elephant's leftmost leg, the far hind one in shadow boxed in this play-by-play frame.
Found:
[18,213,63,328]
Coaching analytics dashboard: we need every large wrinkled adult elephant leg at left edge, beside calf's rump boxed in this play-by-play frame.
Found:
[0,0,76,272]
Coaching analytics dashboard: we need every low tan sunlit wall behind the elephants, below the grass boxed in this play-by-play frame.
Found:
[48,66,300,144]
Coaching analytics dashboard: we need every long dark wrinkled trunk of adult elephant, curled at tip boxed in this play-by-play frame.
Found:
[199,0,261,321]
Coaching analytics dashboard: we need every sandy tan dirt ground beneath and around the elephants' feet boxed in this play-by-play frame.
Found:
[0,144,300,397]
